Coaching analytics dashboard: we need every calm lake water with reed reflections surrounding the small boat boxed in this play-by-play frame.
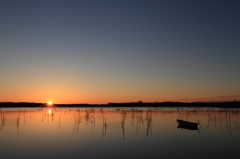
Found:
[0,108,240,159]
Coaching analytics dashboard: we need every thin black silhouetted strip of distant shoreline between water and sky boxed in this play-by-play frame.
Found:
[0,101,240,108]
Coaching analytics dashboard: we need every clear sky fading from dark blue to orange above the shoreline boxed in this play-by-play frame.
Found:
[0,0,240,104]
